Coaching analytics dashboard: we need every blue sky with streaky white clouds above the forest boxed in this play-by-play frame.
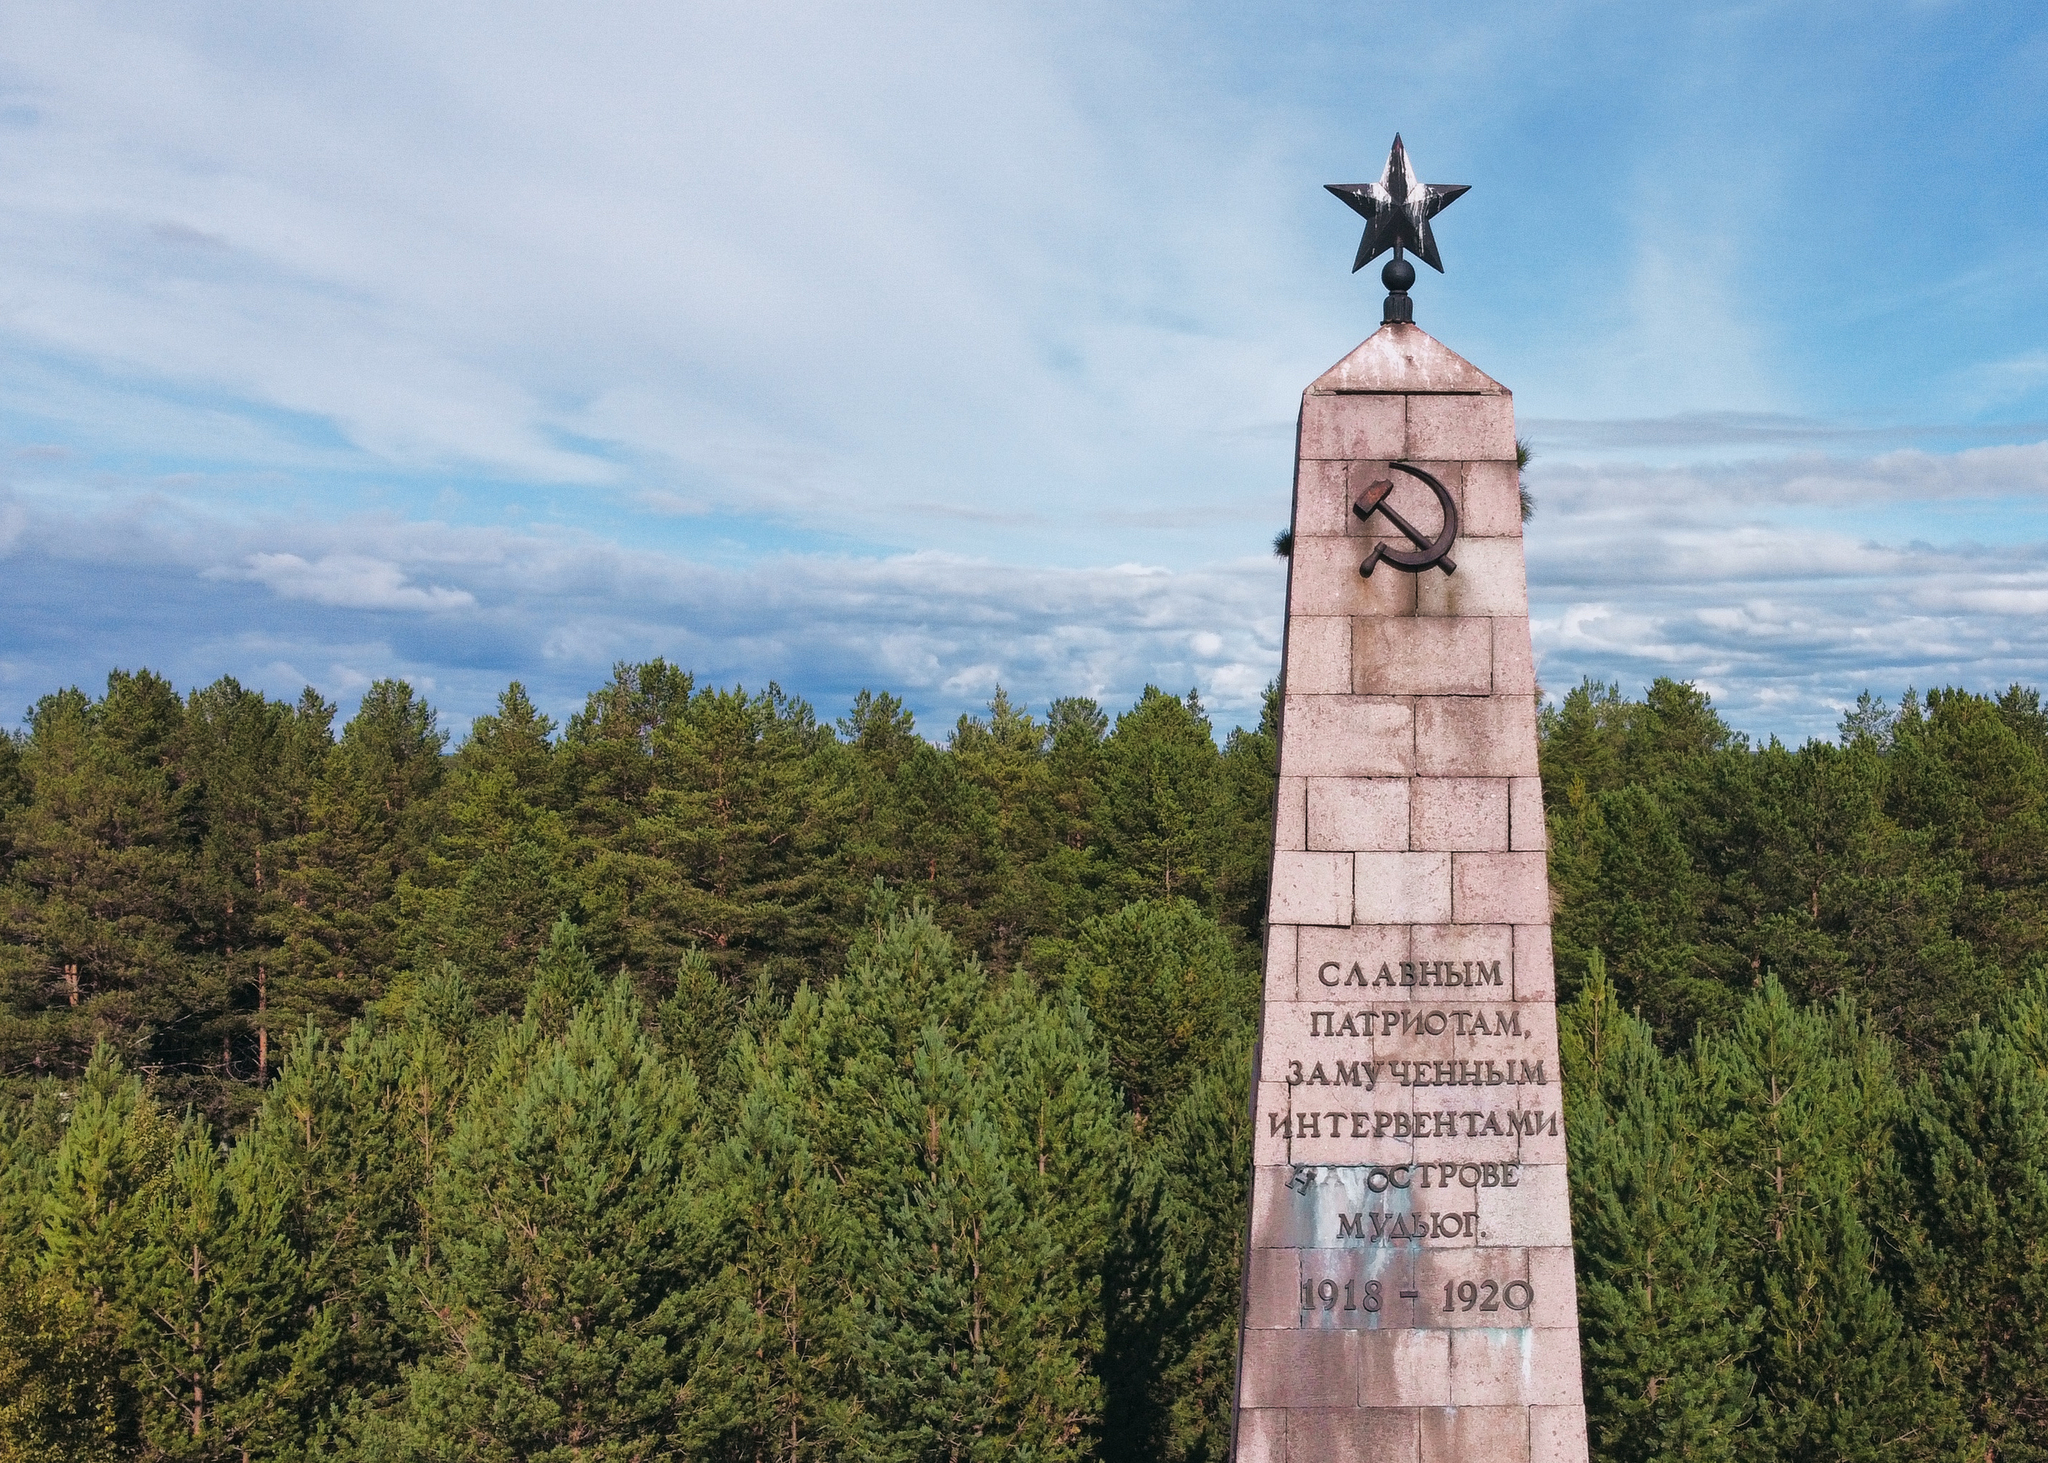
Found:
[0,0,2048,740]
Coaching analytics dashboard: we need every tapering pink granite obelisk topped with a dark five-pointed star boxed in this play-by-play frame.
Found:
[1235,137,1585,1463]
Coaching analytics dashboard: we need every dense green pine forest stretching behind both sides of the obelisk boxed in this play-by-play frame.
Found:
[0,662,2048,1463]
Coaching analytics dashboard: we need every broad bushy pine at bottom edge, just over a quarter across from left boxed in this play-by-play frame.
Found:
[393,979,705,1463]
